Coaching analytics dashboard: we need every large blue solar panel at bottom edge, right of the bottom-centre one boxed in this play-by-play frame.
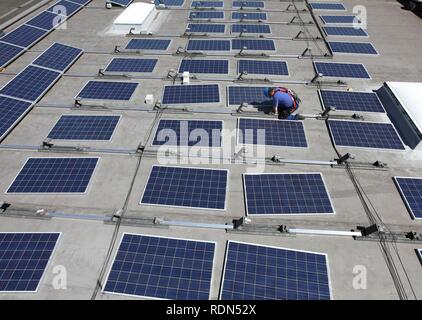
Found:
[220,240,331,300]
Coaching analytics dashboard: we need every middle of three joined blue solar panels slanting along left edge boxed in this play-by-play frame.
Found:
[0,65,60,101]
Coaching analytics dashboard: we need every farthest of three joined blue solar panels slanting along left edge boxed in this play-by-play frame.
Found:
[33,42,83,72]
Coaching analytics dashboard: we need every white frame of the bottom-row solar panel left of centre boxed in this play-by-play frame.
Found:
[101,232,218,300]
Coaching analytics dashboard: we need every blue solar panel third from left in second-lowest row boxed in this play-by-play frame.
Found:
[243,173,334,215]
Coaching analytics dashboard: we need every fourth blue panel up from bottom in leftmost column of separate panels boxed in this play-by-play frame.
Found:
[77,81,138,100]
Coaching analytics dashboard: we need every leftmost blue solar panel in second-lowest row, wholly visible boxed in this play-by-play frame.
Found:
[7,158,99,193]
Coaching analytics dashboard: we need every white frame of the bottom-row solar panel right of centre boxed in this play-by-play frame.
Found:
[219,240,333,300]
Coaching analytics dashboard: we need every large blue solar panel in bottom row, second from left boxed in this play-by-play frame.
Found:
[104,233,215,300]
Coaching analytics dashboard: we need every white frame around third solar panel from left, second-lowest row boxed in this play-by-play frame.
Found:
[242,172,336,218]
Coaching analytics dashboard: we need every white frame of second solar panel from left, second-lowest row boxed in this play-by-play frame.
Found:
[139,165,230,212]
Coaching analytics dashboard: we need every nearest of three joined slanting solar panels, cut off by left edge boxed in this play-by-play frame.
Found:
[0,96,32,140]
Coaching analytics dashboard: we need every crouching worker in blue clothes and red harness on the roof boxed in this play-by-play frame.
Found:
[264,87,301,120]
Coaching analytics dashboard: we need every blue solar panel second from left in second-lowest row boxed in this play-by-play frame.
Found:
[140,166,228,210]
